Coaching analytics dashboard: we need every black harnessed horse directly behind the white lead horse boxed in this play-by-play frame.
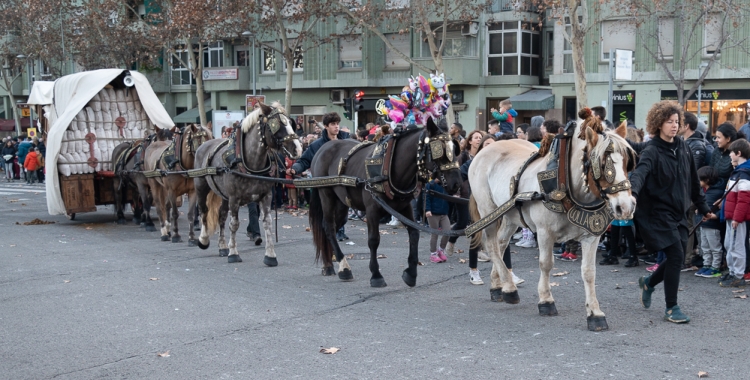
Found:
[308,118,461,287]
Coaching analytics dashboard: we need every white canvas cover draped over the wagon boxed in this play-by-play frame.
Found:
[45,69,174,215]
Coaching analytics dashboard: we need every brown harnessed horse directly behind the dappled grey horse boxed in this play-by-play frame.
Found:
[143,124,213,246]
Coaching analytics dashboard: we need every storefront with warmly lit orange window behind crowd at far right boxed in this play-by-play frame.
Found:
[661,90,750,134]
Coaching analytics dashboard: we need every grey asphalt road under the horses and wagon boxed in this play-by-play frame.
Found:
[0,183,750,379]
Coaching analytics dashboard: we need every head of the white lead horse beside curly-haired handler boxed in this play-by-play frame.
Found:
[583,122,636,219]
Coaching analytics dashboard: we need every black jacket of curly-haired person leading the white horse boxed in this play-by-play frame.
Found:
[630,136,710,252]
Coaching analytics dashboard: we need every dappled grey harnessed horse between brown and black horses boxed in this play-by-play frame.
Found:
[194,104,302,267]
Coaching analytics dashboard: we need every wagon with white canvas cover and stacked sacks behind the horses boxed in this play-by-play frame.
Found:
[30,69,174,218]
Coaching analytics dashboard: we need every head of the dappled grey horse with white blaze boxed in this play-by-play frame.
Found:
[256,103,302,160]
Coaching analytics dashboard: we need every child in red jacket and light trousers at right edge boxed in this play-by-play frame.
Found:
[719,140,750,287]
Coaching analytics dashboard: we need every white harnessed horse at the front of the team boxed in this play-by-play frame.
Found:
[467,109,636,331]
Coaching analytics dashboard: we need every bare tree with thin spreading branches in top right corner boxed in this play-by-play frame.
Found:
[619,0,750,105]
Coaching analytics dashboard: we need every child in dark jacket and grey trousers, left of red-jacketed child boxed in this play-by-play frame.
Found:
[695,166,726,278]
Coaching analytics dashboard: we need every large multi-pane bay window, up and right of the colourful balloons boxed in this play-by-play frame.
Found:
[487,21,541,75]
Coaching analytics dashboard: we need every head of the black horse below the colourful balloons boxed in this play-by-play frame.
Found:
[419,117,463,194]
